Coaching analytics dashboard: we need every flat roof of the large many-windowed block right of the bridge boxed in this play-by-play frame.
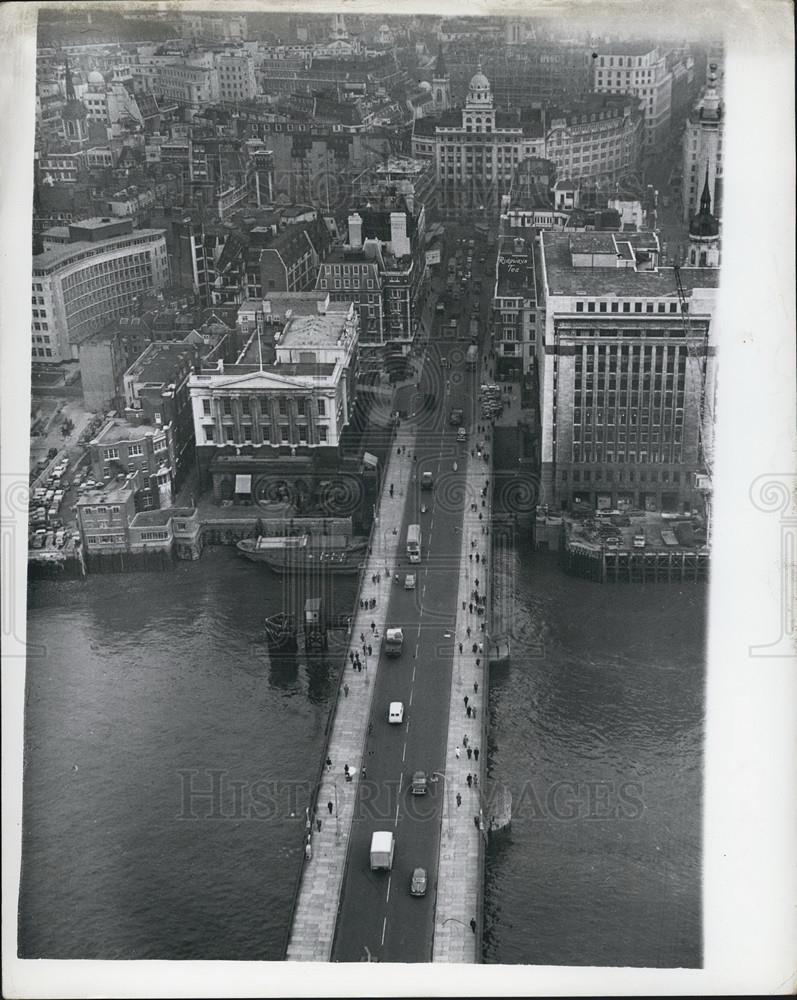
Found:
[542,232,719,297]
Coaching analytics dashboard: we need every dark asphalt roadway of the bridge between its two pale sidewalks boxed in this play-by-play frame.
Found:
[332,315,486,962]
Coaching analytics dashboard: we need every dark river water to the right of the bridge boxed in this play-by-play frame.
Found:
[485,550,707,968]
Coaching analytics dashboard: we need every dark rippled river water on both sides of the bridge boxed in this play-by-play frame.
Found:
[20,549,706,966]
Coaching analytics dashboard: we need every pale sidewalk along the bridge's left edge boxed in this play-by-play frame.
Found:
[286,424,416,962]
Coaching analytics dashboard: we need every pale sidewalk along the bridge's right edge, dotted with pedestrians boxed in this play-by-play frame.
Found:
[432,416,491,962]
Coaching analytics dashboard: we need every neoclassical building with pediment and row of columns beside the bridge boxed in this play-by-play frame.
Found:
[189,294,359,503]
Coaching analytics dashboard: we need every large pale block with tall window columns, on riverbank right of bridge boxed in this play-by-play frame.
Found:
[537,232,719,510]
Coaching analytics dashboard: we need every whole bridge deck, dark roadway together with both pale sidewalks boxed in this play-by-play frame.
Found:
[286,230,489,962]
